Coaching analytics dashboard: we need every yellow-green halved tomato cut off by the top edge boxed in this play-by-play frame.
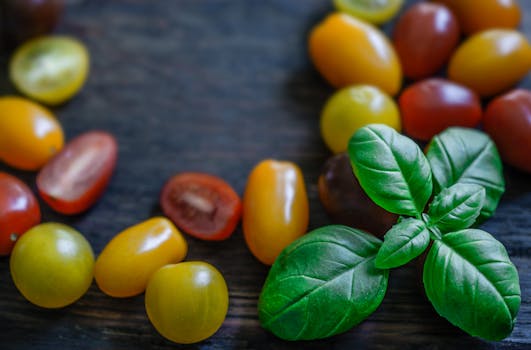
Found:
[334,0,404,24]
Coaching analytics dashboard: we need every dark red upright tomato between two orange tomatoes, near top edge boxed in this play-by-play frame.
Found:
[393,3,459,79]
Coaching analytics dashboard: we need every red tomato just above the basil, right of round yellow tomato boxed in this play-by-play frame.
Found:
[398,79,482,141]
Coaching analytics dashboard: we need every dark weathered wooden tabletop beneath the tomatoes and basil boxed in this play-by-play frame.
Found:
[0,0,531,349]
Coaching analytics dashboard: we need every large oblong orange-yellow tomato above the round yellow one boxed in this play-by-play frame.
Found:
[309,13,402,95]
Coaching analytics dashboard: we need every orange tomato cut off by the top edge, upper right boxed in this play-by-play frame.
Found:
[436,0,522,34]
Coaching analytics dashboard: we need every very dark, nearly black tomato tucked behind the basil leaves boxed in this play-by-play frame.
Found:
[319,153,398,237]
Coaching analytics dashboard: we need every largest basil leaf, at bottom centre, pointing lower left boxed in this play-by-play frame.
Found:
[258,225,389,340]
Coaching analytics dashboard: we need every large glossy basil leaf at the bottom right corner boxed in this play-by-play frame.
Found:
[423,229,521,340]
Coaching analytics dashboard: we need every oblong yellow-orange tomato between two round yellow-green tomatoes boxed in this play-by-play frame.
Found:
[94,217,188,298]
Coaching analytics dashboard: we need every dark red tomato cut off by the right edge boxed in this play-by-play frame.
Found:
[483,89,531,173]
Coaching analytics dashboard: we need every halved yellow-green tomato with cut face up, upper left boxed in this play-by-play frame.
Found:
[9,36,89,105]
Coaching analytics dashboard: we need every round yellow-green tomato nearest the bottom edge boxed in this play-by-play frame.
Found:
[145,261,229,344]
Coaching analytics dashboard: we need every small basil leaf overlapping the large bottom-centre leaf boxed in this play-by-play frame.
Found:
[375,218,430,269]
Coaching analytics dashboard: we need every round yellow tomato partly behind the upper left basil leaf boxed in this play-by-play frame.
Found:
[321,85,400,153]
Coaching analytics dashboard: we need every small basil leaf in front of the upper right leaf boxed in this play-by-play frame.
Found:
[428,183,485,232]
